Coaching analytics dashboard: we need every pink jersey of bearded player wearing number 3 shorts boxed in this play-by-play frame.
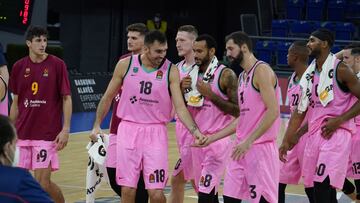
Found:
[236,61,281,144]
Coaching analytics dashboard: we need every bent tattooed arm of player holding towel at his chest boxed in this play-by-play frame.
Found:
[197,68,239,117]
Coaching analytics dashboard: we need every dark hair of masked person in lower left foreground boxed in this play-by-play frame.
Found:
[0,115,16,156]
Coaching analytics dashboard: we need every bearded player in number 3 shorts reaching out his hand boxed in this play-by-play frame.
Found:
[198,32,280,203]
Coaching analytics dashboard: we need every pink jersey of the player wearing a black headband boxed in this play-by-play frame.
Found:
[307,60,355,133]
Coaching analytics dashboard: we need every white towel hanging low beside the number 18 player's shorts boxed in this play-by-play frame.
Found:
[86,135,109,203]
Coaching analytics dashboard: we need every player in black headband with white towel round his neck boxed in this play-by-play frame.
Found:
[283,28,360,202]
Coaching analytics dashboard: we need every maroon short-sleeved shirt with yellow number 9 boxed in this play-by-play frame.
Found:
[10,55,71,141]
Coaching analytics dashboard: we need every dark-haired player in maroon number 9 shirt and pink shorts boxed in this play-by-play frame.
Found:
[10,27,72,202]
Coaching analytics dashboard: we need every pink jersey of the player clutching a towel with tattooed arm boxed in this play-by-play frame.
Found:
[194,65,233,134]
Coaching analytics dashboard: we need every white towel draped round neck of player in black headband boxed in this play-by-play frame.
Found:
[298,53,338,113]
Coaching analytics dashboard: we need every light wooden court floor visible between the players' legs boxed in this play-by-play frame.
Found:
[52,120,351,203]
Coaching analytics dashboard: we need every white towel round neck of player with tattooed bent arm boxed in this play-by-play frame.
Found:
[184,56,219,107]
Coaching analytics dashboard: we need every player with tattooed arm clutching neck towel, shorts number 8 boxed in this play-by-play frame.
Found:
[188,34,239,203]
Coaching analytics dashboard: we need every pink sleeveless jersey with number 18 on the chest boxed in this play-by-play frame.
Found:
[117,55,172,124]
